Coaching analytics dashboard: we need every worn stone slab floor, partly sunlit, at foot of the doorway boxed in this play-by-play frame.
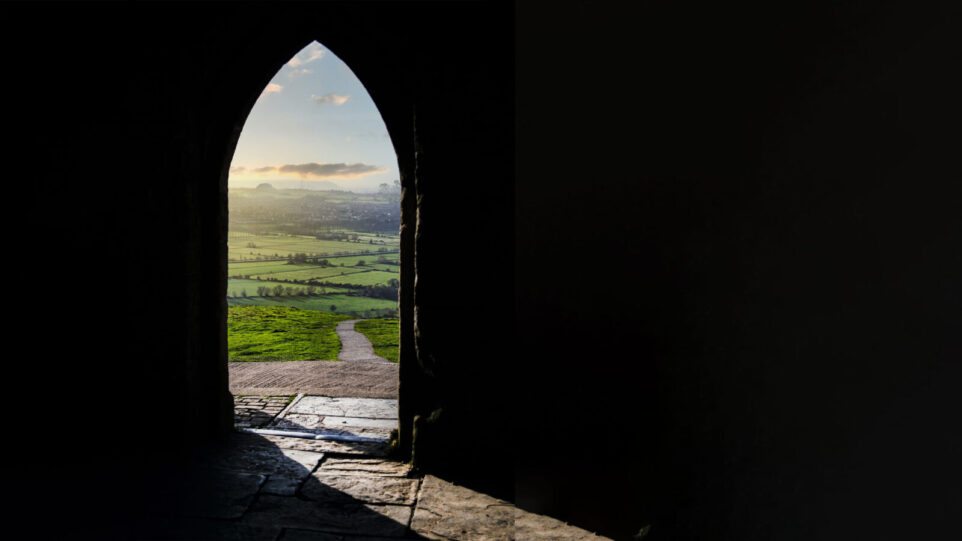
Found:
[211,396,603,541]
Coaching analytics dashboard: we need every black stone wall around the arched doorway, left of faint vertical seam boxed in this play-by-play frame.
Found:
[3,2,514,538]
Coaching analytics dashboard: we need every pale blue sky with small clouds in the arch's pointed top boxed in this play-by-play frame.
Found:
[227,41,400,192]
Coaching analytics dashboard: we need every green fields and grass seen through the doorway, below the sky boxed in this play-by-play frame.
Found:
[225,188,400,361]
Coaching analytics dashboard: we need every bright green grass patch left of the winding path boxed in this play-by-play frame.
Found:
[227,306,349,361]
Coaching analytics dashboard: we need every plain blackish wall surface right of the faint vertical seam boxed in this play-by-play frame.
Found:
[516,2,962,539]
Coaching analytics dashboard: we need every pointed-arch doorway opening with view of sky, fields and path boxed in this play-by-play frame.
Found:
[226,41,401,443]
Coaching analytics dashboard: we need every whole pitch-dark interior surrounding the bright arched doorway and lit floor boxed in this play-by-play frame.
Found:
[0,2,962,540]
